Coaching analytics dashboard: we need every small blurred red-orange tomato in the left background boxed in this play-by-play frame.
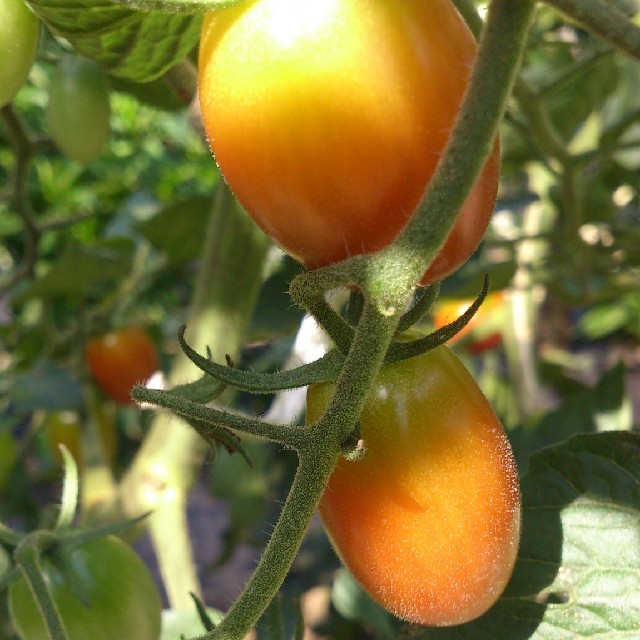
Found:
[85,327,160,404]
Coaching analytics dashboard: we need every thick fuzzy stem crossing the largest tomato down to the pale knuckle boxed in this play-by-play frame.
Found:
[378,0,535,296]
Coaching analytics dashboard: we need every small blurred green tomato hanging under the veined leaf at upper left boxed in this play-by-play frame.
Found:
[47,57,111,163]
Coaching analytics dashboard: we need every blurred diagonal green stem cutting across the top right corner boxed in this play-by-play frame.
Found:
[545,0,640,60]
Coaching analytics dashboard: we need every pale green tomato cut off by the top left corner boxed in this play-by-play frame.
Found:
[0,0,40,107]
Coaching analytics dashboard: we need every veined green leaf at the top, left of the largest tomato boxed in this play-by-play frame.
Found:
[29,0,201,82]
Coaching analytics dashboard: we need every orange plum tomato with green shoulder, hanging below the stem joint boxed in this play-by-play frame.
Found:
[307,345,521,626]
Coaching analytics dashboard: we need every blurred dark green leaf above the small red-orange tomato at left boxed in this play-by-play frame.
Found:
[24,237,135,299]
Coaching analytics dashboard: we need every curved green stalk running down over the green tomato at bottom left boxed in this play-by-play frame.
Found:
[14,532,69,640]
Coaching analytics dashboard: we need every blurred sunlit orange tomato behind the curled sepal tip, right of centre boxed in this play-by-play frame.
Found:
[433,291,507,355]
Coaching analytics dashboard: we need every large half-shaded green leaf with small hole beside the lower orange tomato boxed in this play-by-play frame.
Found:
[428,432,640,640]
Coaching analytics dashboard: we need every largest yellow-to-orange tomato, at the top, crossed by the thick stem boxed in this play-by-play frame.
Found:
[199,0,499,284]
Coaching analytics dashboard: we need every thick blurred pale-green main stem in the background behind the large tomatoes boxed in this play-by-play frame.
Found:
[99,181,269,611]
